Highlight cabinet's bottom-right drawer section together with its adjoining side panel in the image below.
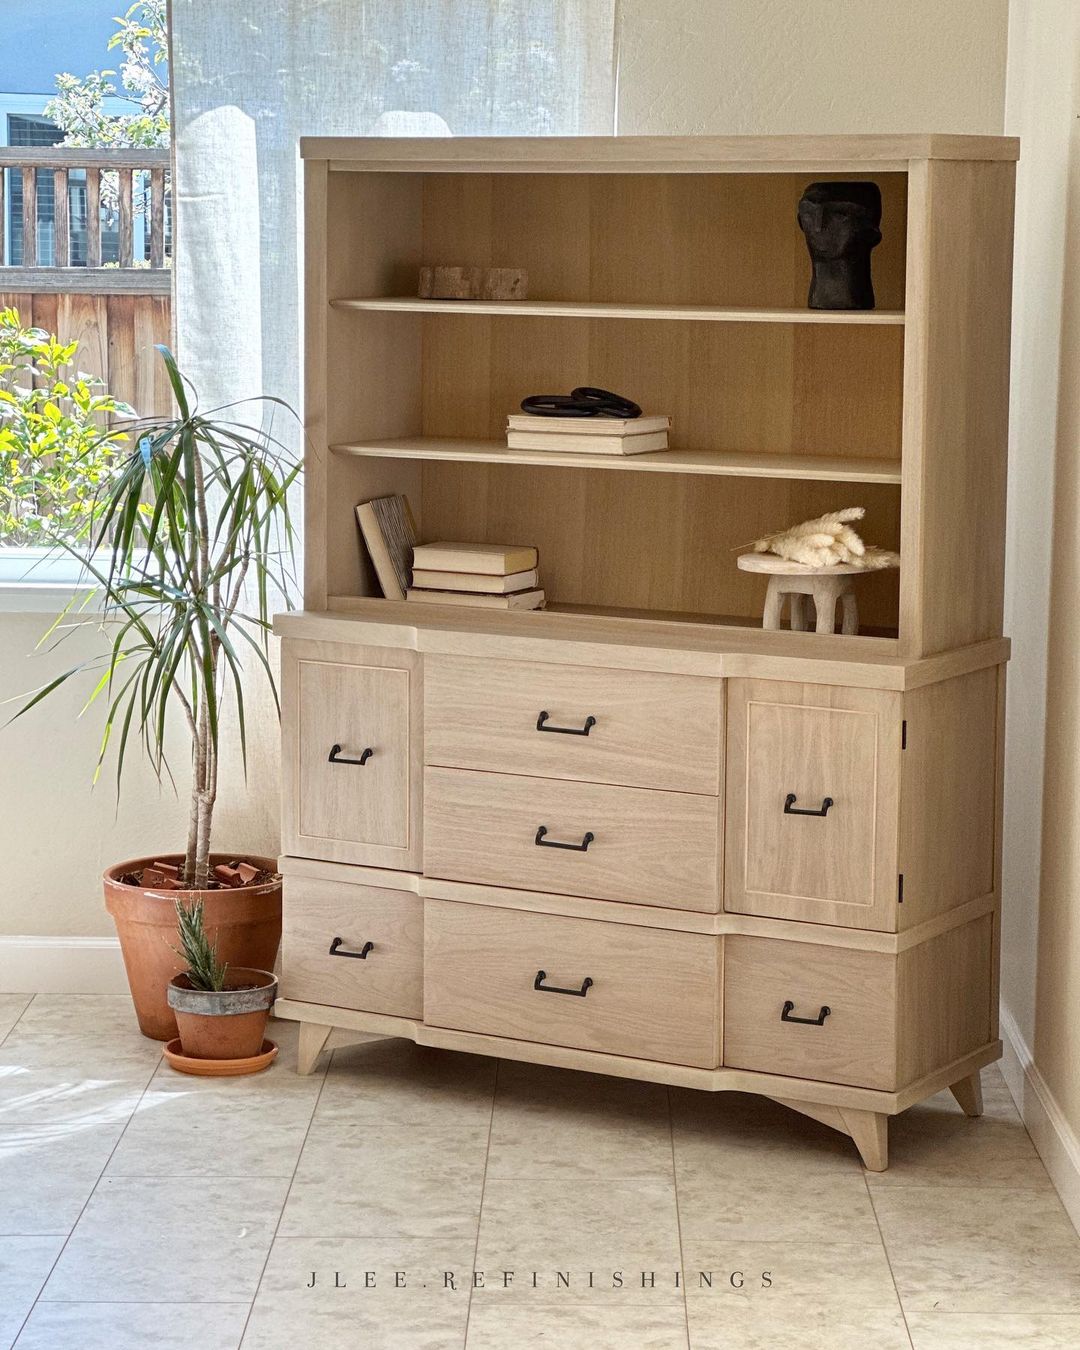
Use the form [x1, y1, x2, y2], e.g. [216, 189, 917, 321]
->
[724, 914, 994, 1091]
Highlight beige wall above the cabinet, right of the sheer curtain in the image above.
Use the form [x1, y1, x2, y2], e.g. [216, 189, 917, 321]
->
[618, 0, 1008, 135]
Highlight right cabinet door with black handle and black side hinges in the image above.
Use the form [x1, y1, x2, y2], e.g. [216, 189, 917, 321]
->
[725, 679, 900, 932]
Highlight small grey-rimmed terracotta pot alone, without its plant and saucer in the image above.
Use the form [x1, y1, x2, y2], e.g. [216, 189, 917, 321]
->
[169, 967, 278, 1060]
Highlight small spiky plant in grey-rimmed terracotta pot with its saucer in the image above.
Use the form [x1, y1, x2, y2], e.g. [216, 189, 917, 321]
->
[166, 899, 278, 1075]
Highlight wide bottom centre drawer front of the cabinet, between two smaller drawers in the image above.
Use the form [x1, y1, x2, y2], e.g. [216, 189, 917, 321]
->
[424, 900, 720, 1068]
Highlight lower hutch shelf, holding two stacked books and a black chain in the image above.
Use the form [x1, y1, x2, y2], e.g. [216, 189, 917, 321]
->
[331, 436, 900, 483]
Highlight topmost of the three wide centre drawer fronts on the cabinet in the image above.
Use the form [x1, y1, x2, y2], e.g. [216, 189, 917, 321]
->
[424, 656, 722, 794]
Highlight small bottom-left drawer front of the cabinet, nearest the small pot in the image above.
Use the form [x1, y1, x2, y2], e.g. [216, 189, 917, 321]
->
[281, 878, 424, 1018]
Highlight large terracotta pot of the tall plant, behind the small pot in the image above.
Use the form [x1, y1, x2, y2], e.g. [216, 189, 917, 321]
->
[103, 853, 281, 1041]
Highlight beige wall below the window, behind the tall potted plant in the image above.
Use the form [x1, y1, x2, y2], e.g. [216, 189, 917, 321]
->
[0, 613, 278, 937]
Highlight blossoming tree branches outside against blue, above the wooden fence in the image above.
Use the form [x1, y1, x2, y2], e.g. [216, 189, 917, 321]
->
[45, 0, 169, 149]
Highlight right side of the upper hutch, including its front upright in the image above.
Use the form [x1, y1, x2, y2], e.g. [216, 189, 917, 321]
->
[900, 162, 1015, 655]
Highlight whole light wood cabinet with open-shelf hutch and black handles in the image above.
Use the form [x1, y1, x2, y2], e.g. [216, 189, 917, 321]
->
[277, 135, 1018, 1169]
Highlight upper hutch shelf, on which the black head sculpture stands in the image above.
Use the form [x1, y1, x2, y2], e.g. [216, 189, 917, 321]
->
[331, 296, 905, 324]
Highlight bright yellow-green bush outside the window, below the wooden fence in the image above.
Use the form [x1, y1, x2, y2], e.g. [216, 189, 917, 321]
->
[0, 309, 135, 547]
